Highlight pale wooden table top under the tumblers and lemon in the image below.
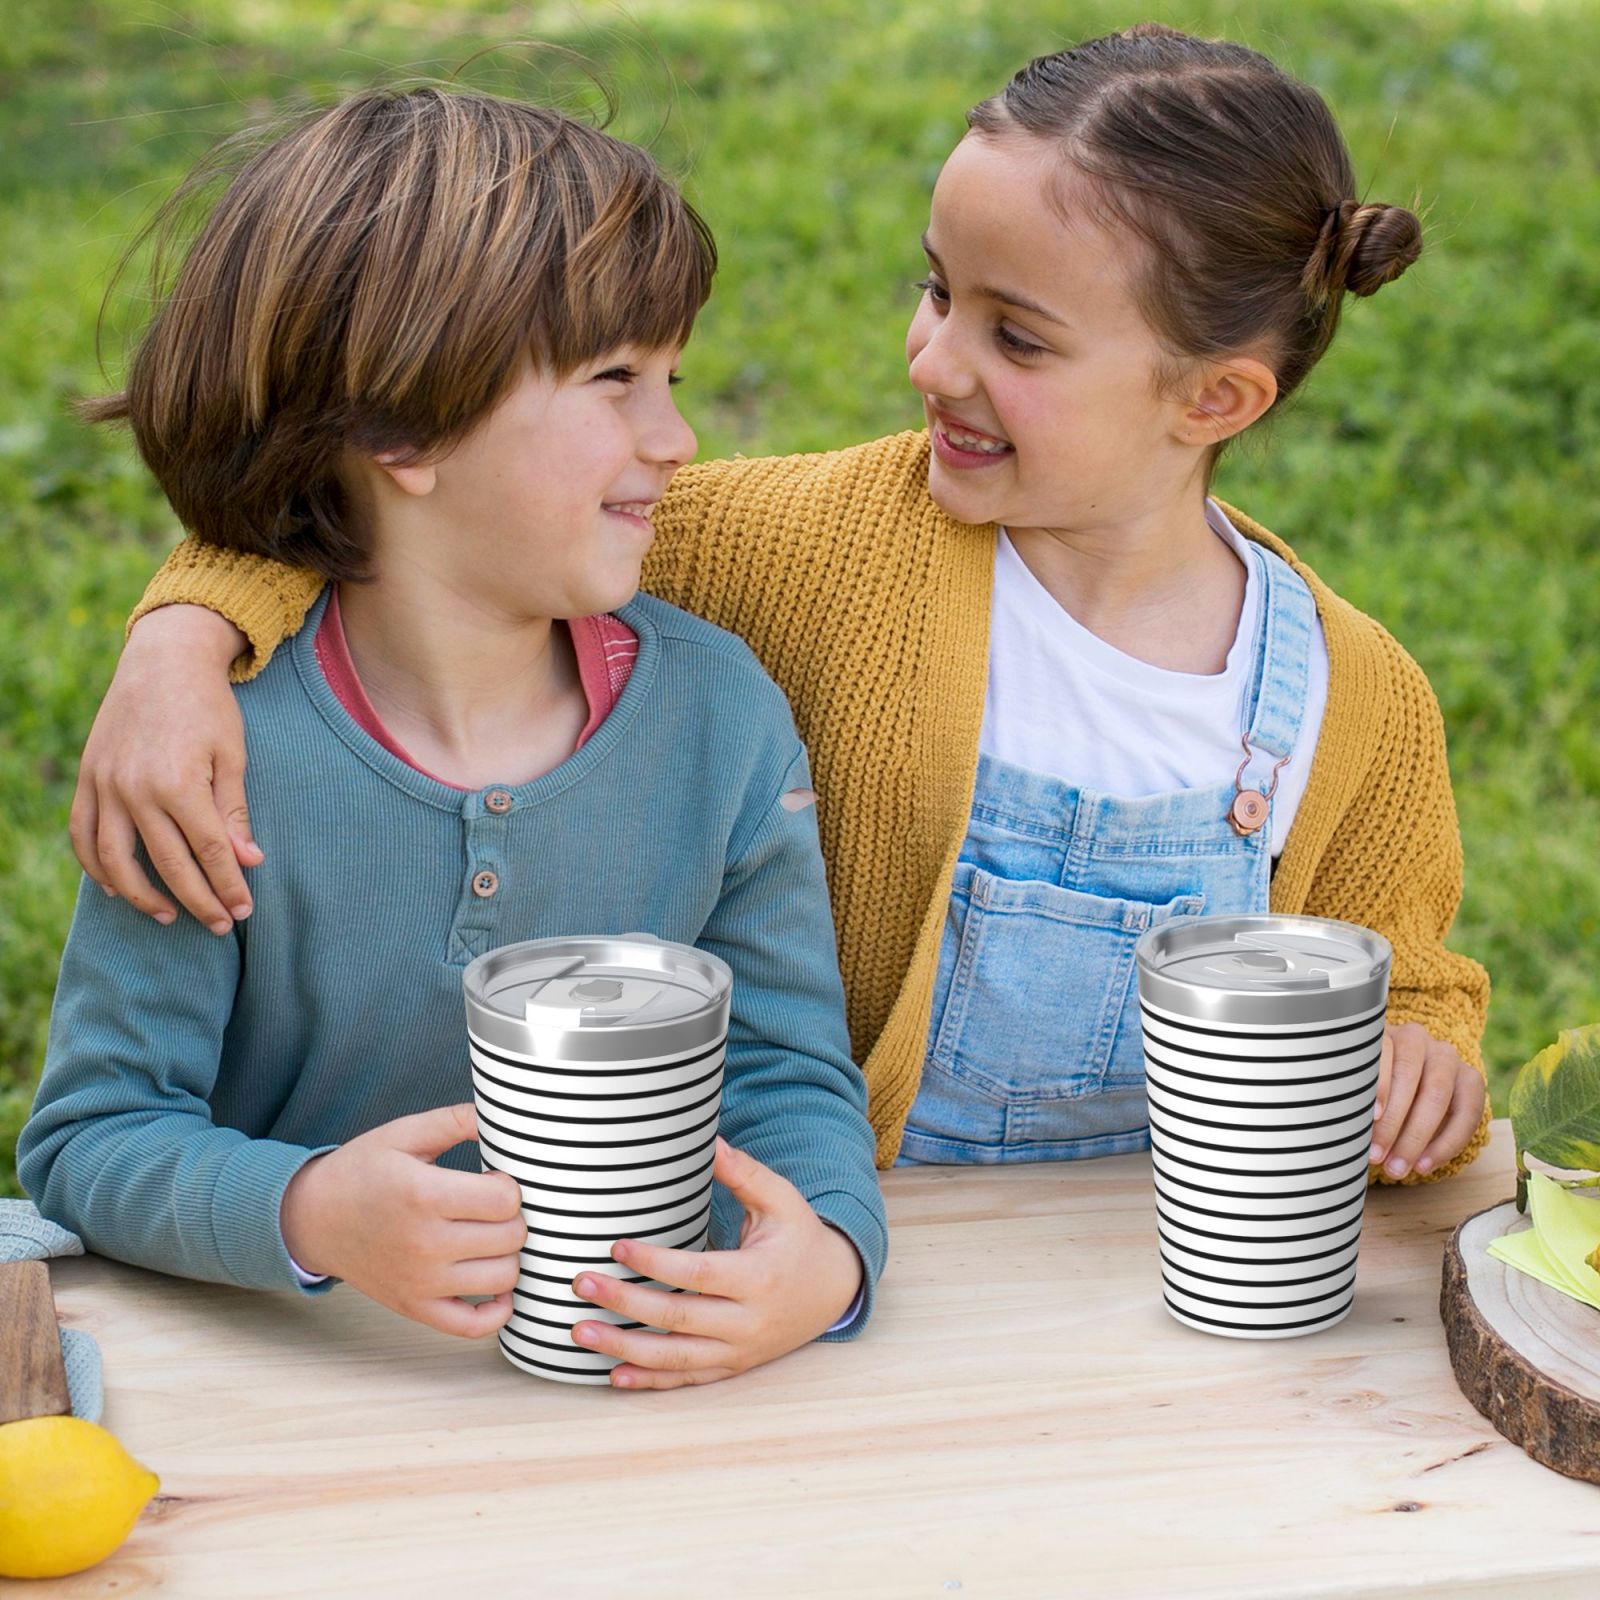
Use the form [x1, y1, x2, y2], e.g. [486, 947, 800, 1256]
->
[34, 1123, 1600, 1600]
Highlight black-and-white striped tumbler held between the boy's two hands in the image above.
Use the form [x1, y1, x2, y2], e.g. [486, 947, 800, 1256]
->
[464, 933, 733, 1384]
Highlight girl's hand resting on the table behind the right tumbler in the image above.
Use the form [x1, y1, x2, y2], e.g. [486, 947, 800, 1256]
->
[1370, 1022, 1485, 1178]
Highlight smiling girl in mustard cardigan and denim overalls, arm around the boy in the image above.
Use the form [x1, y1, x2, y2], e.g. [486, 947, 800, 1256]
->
[62, 26, 1488, 1181]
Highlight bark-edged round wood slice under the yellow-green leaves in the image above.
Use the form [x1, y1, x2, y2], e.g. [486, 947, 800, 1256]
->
[1438, 1200, 1600, 1483]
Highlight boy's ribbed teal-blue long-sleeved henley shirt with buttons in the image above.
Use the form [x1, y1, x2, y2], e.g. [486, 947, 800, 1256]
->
[18, 595, 886, 1336]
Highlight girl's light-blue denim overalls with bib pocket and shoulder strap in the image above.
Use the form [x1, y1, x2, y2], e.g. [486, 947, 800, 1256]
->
[899, 544, 1315, 1165]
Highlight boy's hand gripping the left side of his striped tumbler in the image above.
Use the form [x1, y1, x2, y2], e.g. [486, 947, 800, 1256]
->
[282, 1106, 528, 1339]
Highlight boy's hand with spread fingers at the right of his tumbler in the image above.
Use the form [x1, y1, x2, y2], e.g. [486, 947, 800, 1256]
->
[573, 1139, 861, 1389]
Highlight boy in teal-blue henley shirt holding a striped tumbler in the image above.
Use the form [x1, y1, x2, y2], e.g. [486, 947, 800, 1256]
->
[18, 88, 885, 1387]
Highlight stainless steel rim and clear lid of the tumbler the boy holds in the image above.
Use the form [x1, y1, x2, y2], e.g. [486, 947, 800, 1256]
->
[462, 933, 733, 1061]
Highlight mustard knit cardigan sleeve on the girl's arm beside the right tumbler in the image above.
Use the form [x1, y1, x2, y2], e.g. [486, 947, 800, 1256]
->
[1306, 629, 1490, 1182]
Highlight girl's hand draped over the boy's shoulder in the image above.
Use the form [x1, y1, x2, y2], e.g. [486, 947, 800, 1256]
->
[70, 605, 262, 934]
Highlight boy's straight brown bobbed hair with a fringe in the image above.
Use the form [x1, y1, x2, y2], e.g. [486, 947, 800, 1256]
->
[80, 86, 717, 579]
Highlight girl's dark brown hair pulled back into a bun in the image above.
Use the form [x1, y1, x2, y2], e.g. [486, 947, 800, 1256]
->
[966, 22, 1422, 425]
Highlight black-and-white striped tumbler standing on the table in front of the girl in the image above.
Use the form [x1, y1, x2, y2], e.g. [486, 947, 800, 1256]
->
[1138, 915, 1390, 1339]
